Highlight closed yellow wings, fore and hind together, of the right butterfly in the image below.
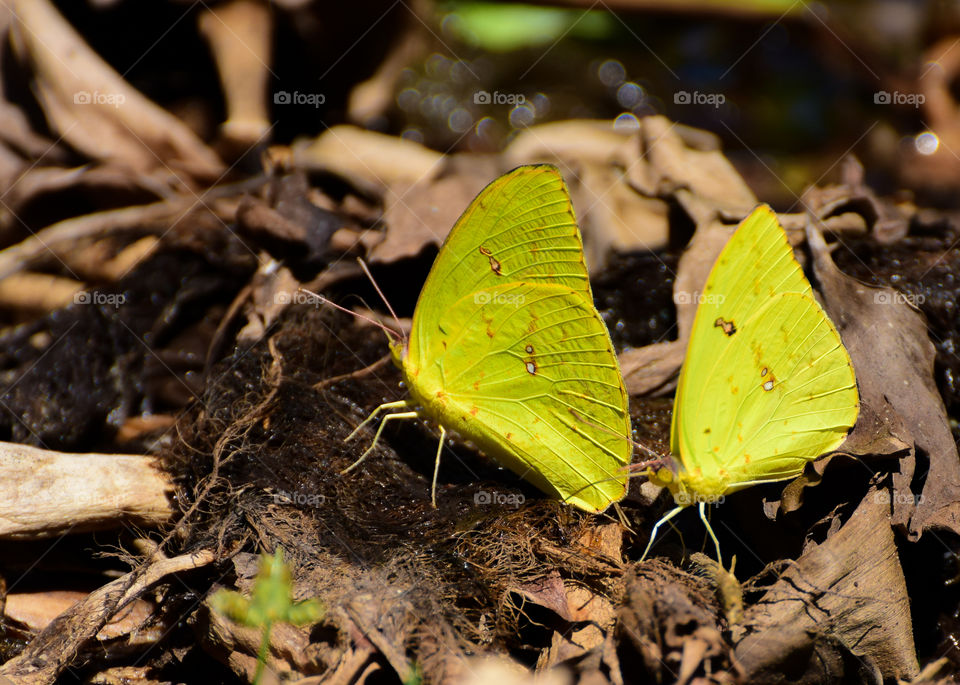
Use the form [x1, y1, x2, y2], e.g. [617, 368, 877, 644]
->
[671, 206, 859, 495]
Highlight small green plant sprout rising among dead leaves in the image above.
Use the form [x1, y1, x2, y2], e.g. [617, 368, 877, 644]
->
[210, 547, 323, 685]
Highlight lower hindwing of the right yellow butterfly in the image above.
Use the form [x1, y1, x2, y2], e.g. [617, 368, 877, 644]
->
[685, 293, 858, 486]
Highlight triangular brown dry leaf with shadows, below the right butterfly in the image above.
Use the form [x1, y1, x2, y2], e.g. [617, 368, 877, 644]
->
[735, 490, 917, 683]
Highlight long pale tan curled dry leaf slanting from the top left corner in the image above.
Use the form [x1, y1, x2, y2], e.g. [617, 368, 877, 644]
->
[12, 0, 223, 180]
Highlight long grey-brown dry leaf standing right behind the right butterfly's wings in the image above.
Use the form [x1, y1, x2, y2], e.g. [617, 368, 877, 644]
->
[807, 226, 960, 539]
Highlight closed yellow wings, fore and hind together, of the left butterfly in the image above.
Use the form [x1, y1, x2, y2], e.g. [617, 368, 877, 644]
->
[402, 165, 632, 511]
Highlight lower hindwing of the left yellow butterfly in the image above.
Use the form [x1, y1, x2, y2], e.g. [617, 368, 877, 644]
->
[411, 282, 632, 511]
